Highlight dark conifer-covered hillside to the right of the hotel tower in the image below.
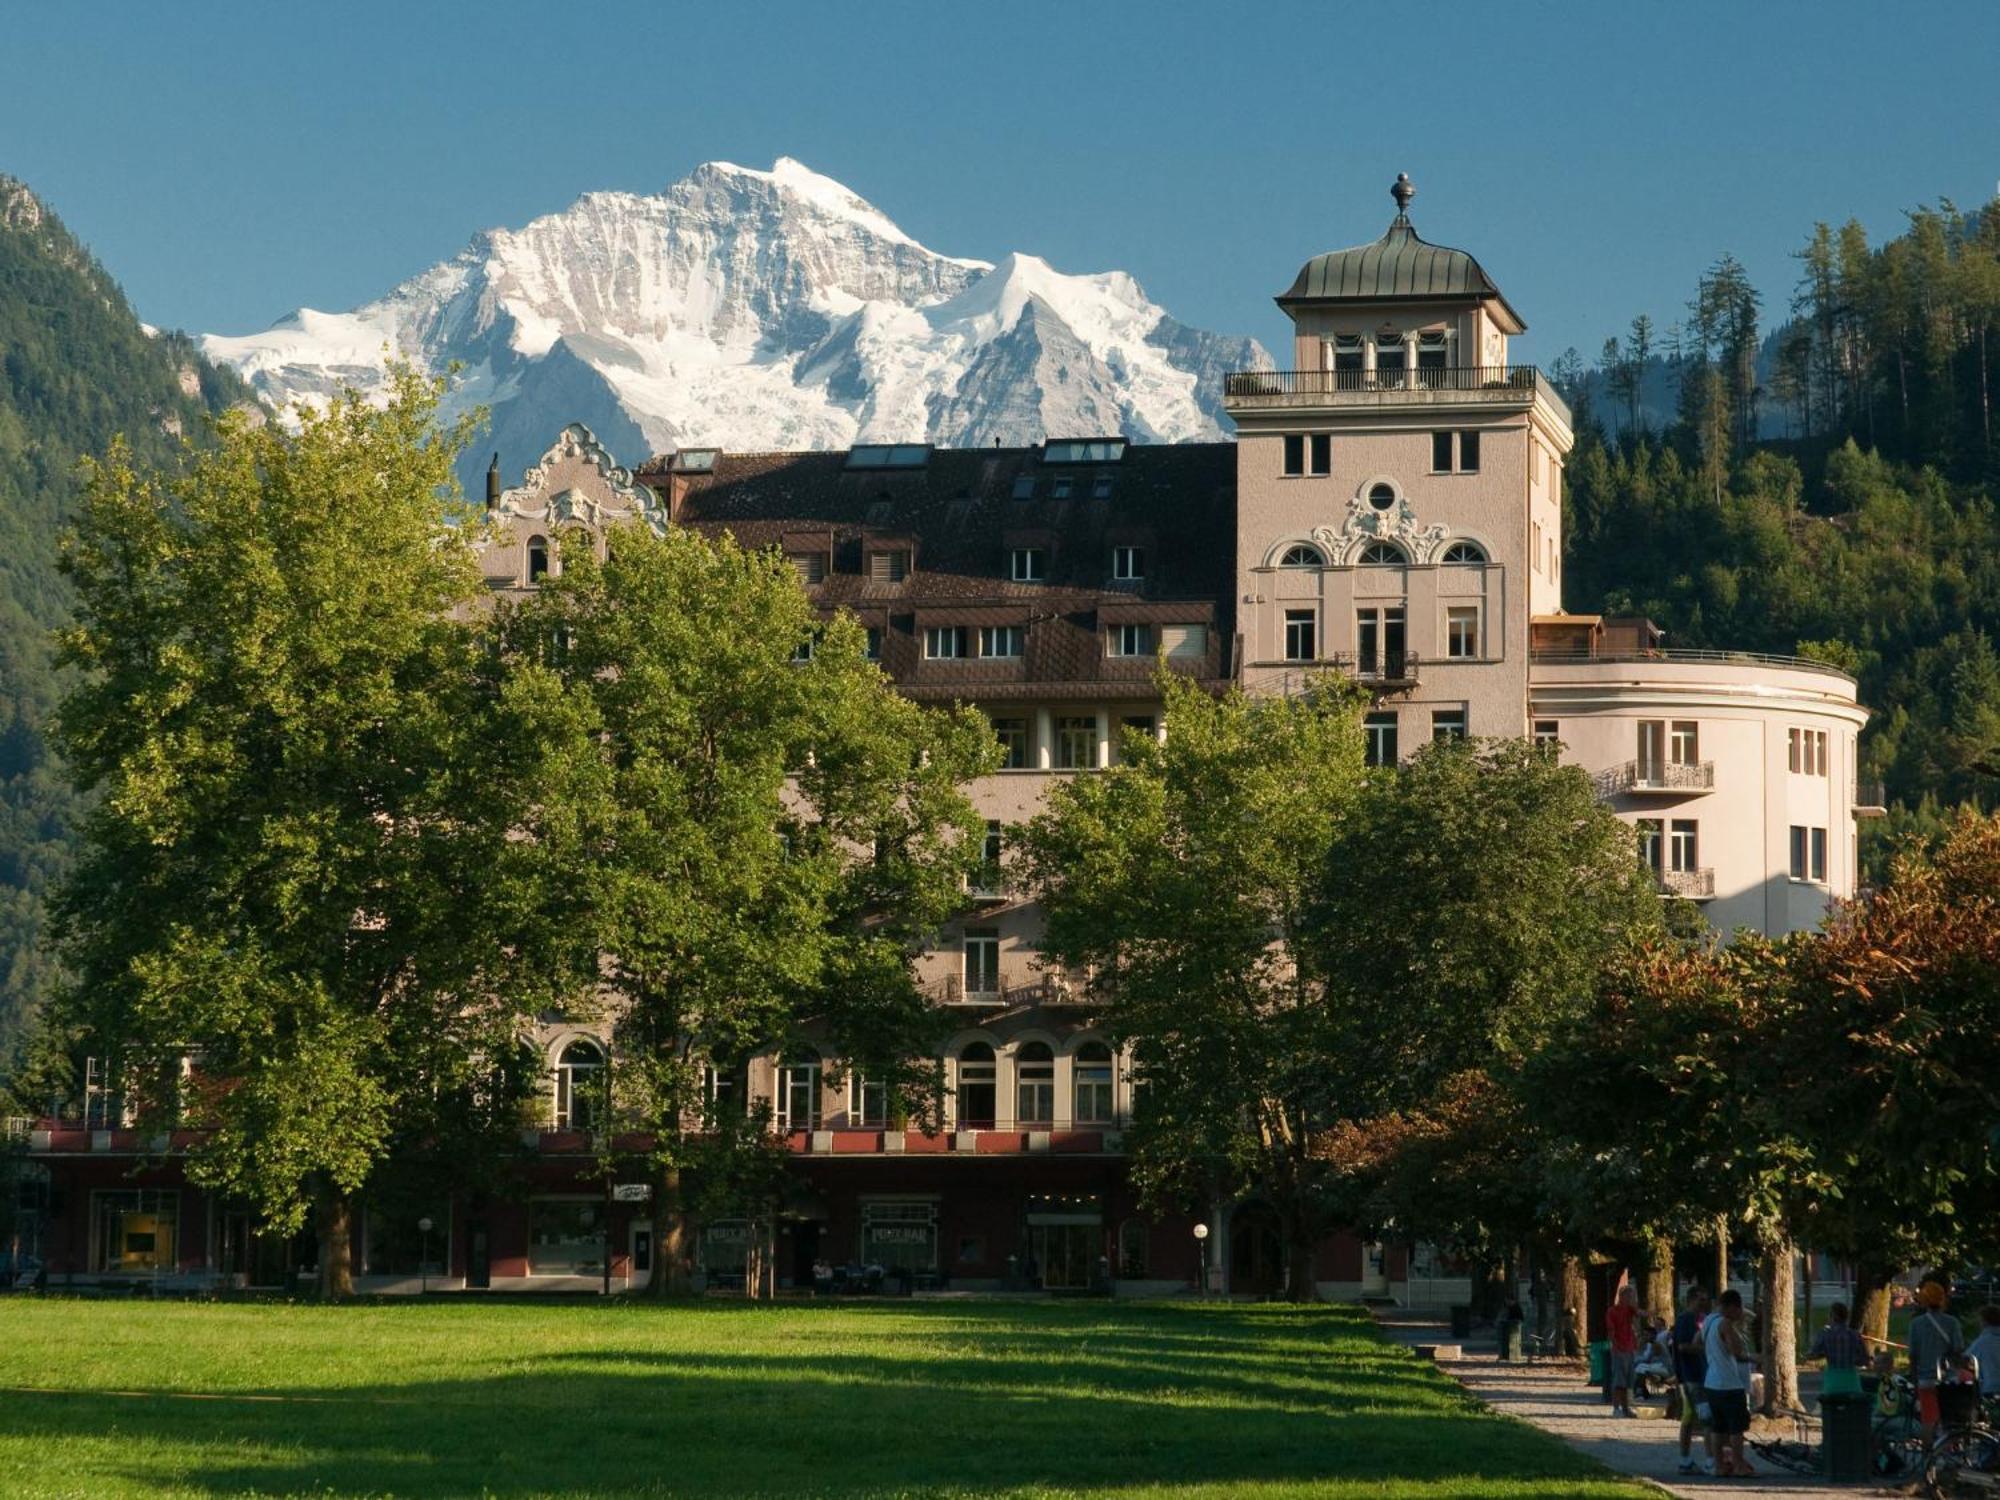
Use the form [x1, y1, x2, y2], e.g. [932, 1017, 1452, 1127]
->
[1562, 202, 2000, 868]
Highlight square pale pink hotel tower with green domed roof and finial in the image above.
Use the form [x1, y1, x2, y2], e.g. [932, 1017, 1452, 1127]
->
[1224, 176, 1572, 760]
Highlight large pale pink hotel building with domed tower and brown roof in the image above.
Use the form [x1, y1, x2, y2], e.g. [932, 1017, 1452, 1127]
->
[15, 178, 1874, 1300]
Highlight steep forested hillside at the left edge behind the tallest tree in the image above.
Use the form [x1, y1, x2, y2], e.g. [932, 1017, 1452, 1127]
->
[0, 176, 248, 1074]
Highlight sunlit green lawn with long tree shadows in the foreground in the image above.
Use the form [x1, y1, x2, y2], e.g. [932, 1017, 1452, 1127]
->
[0, 1298, 1646, 1500]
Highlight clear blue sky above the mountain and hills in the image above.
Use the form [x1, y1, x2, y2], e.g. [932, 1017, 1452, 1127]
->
[0, 0, 2000, 360]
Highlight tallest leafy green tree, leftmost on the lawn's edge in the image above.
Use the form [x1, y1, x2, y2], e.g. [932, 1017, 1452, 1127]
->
[56, 370, 532, 1296]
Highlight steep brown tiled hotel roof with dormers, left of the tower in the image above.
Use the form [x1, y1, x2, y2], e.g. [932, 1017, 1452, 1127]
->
[636, 442, 1236, 698]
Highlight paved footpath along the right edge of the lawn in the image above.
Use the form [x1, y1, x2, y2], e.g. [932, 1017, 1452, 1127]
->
[1376, 1308, 1908, 1500]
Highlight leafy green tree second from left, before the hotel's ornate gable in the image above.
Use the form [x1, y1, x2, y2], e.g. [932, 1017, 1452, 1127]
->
[500, 526, 998, 1296]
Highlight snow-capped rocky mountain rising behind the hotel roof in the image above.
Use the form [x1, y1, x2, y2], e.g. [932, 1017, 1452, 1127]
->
[202, 158, 1270, 484]
